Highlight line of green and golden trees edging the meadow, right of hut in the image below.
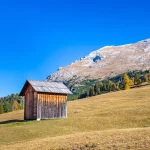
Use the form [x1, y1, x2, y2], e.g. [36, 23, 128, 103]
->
[72, 70, 150, 99]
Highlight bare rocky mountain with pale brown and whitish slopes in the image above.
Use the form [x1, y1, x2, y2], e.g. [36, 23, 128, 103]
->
[47, 39, 150, 82]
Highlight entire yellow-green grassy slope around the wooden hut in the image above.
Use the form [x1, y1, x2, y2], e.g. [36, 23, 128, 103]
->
[0, 86, 150, 149]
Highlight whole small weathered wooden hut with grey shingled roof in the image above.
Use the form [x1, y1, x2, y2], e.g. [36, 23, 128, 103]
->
[20, 80, 72, 120]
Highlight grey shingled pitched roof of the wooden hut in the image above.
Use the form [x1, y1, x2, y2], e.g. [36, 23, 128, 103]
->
[20, 80, 72, 96]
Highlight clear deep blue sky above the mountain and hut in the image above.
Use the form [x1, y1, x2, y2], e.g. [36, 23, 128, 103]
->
[0, 0, 150, 97]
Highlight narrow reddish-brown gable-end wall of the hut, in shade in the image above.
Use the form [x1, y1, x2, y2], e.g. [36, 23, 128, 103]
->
[24, 85, 37, 120]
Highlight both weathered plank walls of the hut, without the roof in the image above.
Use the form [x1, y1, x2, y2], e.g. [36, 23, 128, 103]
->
[24, 85, 67, 120]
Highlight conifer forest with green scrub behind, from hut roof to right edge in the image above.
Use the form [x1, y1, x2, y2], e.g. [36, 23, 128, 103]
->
[66, 70, 150, 100]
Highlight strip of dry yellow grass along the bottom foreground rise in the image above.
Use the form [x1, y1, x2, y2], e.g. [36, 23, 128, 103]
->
[2, 128, 150, 150]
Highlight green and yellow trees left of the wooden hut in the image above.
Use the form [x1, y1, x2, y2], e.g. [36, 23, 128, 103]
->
[0, 94, 24, 114]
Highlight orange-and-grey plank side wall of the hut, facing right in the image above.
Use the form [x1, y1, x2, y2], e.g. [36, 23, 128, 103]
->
[37, 93, 67, 119]
